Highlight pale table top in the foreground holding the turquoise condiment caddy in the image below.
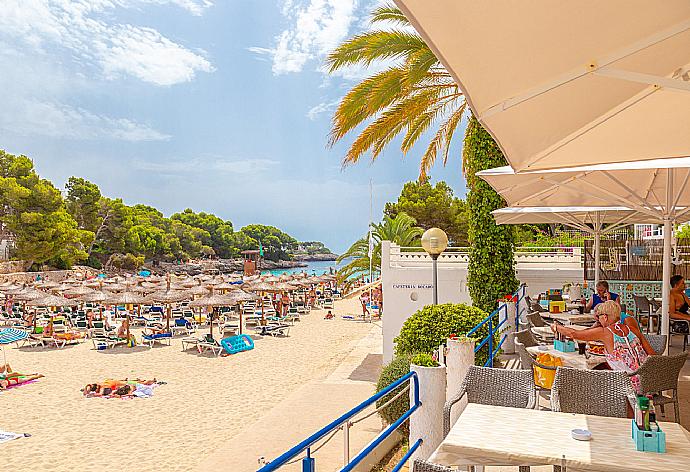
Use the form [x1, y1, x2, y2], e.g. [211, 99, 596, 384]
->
[429, 403, 690, 472]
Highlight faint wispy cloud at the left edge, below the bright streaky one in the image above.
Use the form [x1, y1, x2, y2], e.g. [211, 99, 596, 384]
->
[0, 99, 170, 142]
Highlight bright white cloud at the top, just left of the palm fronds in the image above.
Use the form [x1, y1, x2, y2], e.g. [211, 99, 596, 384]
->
[250, 0, 358, 75]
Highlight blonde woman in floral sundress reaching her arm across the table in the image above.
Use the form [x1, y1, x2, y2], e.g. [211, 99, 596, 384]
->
[551, 300, 656, 392]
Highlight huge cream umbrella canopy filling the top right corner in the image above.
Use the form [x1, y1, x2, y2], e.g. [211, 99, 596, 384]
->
[395, 0, 690, 171]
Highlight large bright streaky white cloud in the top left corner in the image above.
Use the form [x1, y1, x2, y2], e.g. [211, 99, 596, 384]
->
[0, 0, 214, 85]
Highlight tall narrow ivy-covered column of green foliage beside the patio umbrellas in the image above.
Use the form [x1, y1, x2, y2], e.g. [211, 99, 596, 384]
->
[463, 116, 519, 312]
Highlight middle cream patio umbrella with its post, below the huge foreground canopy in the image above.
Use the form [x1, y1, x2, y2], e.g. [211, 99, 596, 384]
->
[477, 157, 690, 340]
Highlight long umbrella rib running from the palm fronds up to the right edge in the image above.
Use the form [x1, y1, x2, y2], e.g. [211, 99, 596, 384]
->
[479, 19, 690, 121]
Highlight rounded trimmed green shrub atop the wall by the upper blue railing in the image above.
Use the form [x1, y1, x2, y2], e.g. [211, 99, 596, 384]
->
[394, 303, 492, 365]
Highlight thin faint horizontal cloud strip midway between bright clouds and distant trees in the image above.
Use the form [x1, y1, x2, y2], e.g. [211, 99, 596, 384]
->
[133, 158, 279, 176]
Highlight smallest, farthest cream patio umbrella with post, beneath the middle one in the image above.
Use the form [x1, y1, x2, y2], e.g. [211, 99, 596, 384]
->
[491, 206, 690, 286]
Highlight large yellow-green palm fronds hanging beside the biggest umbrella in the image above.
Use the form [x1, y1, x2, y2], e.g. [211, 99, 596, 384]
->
[326, 4, 467, 179]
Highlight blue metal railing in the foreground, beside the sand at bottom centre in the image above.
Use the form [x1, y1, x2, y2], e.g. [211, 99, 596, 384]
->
[258, 372, 422, 472]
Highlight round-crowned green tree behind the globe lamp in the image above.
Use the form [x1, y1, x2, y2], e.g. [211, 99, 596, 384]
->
[384, 179, 469, 246]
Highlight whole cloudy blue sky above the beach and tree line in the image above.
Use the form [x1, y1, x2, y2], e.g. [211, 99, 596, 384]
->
[0, 0, 465, 252]
